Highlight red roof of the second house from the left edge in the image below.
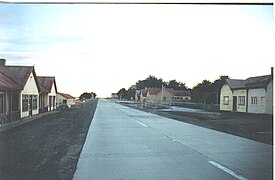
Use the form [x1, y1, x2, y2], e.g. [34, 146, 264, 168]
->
[37, 76, 56, 93]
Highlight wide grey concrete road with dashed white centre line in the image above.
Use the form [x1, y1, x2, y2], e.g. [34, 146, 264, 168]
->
[74, 99, 273, 180]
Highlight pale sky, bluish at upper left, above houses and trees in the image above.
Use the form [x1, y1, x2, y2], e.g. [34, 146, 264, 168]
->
[0, 3, 275, 97]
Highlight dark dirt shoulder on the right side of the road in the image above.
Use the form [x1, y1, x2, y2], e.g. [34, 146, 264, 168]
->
[125, 104, 273, 144]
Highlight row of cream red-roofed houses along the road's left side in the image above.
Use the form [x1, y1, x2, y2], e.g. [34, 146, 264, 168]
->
[0, 59, 75, 125]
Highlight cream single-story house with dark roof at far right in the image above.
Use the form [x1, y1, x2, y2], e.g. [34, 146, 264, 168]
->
[220, 69, 273, 114]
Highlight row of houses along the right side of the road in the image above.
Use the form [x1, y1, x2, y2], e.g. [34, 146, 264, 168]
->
[126, 68, 273, 114]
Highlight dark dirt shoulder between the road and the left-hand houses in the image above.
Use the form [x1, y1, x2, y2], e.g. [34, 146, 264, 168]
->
[0, 100, 97, 180]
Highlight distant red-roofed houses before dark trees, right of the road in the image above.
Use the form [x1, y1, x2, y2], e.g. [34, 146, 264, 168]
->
[135, 87, 191, 104]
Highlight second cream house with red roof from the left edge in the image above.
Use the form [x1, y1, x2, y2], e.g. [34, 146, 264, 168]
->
[37, 76, 57, 113]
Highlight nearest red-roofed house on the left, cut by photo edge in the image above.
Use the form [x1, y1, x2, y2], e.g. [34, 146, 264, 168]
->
[0, 59, 40, 124]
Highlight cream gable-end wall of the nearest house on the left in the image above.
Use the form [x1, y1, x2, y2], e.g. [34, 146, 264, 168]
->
[20, 73, 39, 118]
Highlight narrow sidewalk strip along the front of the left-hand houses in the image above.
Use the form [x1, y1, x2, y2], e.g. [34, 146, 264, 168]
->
[0, 110, 59, 133]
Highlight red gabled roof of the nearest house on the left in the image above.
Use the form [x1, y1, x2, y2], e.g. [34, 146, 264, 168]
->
[0, 66, 40, 91]
